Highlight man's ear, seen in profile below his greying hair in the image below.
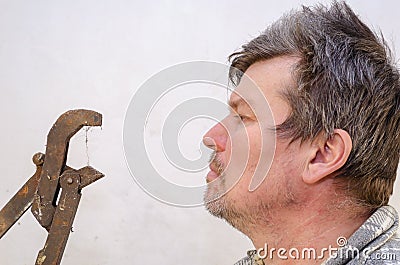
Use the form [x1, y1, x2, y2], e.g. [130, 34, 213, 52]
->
[303, 129, 353, 184]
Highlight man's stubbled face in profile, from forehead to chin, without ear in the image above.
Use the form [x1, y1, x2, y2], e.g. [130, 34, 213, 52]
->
[204, 57, 302, 229]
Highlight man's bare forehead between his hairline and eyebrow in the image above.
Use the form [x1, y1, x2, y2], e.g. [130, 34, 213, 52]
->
[230, 56, 299, 105]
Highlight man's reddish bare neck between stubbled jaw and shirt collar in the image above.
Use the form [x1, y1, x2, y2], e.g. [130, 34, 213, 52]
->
[246, 197, 369, 264]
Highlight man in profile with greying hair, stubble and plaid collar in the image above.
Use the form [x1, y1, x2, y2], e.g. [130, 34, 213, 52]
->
[203, 2, 400, 264]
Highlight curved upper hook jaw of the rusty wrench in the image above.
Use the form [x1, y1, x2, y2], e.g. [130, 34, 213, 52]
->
[31, 109, 102, 230]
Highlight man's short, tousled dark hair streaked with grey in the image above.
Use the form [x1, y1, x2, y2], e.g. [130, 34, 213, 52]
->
[229, 1, 400, 210]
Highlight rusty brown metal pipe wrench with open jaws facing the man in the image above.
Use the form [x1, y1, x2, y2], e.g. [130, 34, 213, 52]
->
[0, 110, 104, 265]
